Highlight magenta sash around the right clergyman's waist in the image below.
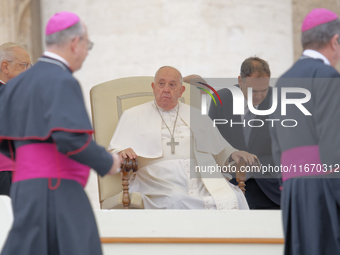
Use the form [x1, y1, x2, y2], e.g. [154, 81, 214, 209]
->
[281, 145, 330, 181]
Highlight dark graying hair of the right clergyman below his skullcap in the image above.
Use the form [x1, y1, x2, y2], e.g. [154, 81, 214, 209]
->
[301, 19, 340, 49]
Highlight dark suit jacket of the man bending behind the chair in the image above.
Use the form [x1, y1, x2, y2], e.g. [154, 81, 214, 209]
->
[209, 85, 281, 208]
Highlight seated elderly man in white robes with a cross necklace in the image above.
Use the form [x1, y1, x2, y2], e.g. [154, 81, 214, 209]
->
[109, 66, 256, 209]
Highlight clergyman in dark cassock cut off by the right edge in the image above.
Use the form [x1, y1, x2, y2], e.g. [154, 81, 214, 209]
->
[271, 8, 340, 255]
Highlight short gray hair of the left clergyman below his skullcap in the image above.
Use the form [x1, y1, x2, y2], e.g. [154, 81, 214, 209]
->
[45, 21, 85, 46]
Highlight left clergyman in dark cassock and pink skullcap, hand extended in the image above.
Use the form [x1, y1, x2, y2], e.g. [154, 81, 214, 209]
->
[0, 12, 120, 255]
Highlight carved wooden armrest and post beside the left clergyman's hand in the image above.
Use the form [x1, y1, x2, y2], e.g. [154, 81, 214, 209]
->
[120, 158, 138, 209]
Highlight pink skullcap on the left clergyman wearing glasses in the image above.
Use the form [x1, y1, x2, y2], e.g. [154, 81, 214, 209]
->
[45, 12, 80, 35]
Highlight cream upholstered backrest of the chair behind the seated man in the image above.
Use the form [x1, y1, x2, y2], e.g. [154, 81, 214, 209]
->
[90, 76, 194, 207]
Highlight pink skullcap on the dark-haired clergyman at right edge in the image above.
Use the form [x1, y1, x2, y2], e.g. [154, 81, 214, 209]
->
[301, 8, 338, 32]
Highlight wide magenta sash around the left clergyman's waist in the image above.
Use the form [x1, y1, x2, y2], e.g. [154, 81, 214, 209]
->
[13, 143, 90, 187]
